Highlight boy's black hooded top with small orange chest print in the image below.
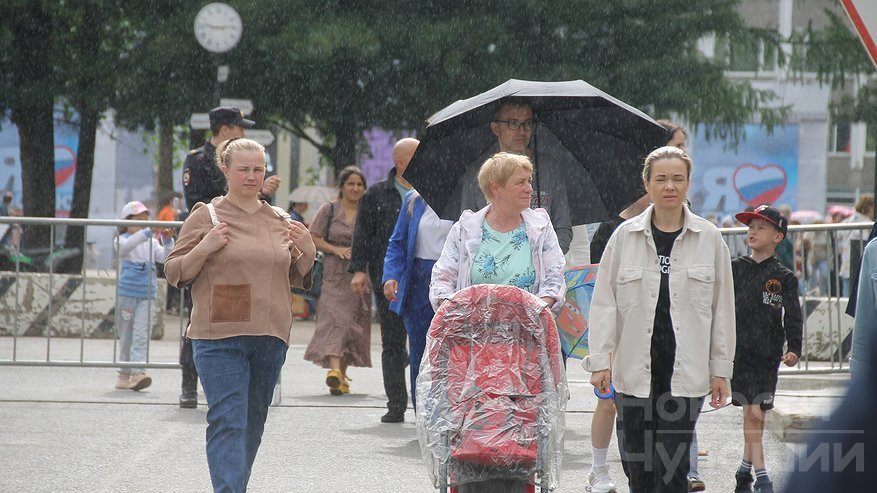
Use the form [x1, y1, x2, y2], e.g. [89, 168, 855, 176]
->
[731, 257, 803, 362]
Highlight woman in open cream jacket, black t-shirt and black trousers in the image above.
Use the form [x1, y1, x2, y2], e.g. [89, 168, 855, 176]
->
[583, 146, 736, 492]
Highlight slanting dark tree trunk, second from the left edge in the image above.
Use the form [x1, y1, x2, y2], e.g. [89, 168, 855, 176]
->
[64, 106, 100, 273]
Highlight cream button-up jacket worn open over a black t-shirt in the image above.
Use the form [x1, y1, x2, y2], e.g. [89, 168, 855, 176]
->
[582, 206, 737, 398]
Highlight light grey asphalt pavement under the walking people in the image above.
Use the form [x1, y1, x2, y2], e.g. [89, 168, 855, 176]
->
[0, 319, 842, 492]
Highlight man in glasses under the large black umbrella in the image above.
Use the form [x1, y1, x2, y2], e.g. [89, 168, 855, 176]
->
[460, 98, 572, 253]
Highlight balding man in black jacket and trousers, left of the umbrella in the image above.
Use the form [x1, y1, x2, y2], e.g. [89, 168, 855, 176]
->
[347, 138, 420, 423]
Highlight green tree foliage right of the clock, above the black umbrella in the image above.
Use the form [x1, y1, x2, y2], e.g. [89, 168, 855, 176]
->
[234, 0, 786, 174]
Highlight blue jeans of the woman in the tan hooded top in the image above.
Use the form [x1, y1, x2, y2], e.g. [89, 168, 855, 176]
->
[192, 336, 287, 493]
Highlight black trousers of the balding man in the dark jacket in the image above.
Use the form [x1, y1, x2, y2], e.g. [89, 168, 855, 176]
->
[372, 279, 408, 413]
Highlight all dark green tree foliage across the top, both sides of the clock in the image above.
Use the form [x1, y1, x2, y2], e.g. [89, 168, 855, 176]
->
[0, 0, 785, 211]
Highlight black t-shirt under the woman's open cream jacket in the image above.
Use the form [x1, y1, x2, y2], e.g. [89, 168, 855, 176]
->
[651, 224, 682, 393]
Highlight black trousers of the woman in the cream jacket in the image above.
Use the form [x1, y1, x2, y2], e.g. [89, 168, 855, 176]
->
[615, 390, 703, 493]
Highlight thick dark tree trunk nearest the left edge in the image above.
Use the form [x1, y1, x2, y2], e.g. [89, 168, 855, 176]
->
[12, 103, 55, 248]
